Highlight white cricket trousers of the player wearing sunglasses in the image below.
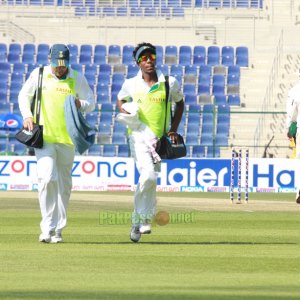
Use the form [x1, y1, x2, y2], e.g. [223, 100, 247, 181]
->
[129, 131, 160, 224]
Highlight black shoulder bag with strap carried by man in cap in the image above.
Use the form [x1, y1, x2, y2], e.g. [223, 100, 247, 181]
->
[16, 67, 44, 148]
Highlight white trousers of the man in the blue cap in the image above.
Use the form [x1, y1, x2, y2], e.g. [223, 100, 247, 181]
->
[35, 143, 75, 234]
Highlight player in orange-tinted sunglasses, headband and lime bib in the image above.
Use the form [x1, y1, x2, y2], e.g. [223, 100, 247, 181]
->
[117, 43, 184, 242]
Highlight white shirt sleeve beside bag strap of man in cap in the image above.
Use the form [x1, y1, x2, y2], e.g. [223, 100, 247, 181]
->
[18, 68, 39, 120]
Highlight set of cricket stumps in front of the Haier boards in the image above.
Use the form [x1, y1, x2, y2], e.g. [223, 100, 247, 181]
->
[230, 148, 249, 203]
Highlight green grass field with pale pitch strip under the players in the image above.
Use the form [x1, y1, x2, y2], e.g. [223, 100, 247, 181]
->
[0, 192, 300, 300]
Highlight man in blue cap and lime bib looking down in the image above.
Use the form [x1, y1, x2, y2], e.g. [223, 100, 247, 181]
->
[19, 44, 95, 243]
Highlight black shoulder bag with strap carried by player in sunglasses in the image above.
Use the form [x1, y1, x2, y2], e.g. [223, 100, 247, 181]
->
[156, 76, 186, 159]
